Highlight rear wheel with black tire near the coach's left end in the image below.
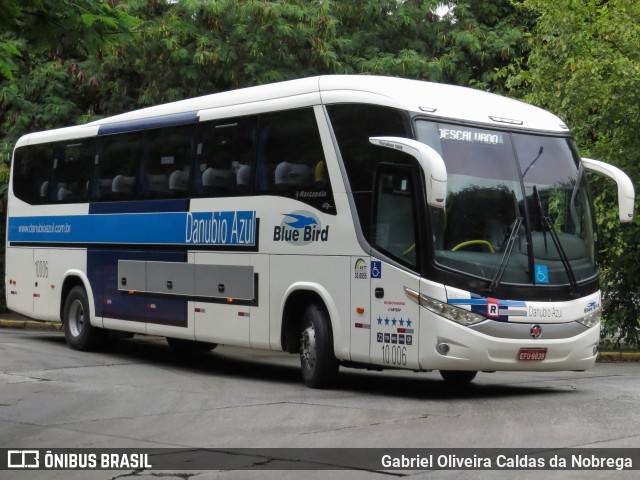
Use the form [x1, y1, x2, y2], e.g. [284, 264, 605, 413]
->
[62, 286, 104, 351]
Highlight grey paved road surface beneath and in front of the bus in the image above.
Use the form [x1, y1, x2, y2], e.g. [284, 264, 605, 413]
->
[0, 329, 640, 480]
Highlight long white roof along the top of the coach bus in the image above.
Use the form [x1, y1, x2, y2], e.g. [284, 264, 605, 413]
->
[16, 75, 568, 146]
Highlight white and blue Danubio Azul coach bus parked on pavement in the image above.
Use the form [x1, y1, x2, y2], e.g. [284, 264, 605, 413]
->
[5, 76, 634, 387]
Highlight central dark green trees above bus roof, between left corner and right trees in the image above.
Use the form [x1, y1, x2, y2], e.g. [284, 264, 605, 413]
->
[76, 0, 525, 110]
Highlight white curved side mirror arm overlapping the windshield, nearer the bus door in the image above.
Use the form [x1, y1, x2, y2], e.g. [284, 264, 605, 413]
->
[369, 137, 447, 208]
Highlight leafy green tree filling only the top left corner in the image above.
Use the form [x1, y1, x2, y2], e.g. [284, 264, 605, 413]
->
[0, 0, 136, 159]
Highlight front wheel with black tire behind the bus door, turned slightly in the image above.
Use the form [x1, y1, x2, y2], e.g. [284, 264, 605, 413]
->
[300, 304, 340, 388]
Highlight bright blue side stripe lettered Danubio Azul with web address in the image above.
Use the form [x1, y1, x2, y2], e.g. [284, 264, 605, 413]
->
[7, 210, 257, 247]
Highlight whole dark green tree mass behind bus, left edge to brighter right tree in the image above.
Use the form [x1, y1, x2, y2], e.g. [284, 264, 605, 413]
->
[0, 0, 526, 156]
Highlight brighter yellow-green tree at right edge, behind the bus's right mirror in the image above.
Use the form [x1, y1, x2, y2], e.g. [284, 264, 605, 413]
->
[503, 0, 640, 345]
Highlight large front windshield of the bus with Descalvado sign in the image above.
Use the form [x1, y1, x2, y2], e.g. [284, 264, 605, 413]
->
[416, 120, 597, 289]
